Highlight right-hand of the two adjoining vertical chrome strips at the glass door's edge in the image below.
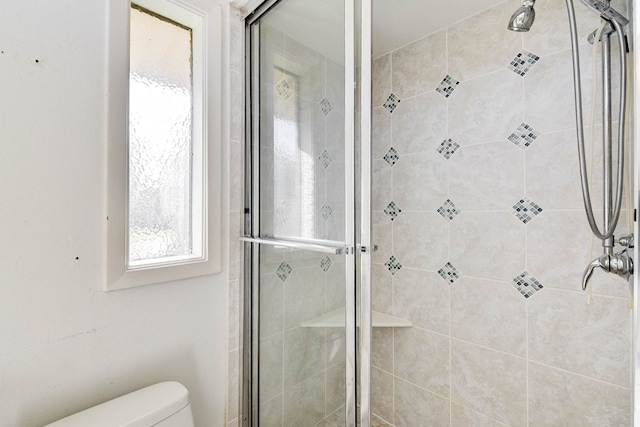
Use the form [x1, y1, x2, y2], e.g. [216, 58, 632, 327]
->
[358, 0, 377, 427]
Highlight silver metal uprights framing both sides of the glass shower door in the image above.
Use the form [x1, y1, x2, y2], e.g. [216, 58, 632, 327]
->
[240, 0, 374, 427]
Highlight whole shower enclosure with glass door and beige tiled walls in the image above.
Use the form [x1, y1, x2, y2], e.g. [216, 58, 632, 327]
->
[242, 0, 638, 427]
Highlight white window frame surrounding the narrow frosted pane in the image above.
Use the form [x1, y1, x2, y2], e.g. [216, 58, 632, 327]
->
[104, 0, 222, 291]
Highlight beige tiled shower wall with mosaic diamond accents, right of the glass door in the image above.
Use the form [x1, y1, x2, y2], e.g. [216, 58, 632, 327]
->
[372, 0, 631, 426]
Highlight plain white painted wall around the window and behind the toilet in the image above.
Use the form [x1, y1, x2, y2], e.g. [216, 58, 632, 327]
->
[0, 0, 229, 427]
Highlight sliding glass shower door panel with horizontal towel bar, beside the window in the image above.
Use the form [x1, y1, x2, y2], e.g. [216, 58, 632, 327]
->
[243, 0, 356, 427]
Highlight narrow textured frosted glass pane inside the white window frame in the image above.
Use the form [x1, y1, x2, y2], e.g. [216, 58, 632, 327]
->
[128, 5, 196, 268]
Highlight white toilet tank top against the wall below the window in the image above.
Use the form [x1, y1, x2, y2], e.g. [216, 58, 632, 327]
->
[45, 381, 194, 427]
